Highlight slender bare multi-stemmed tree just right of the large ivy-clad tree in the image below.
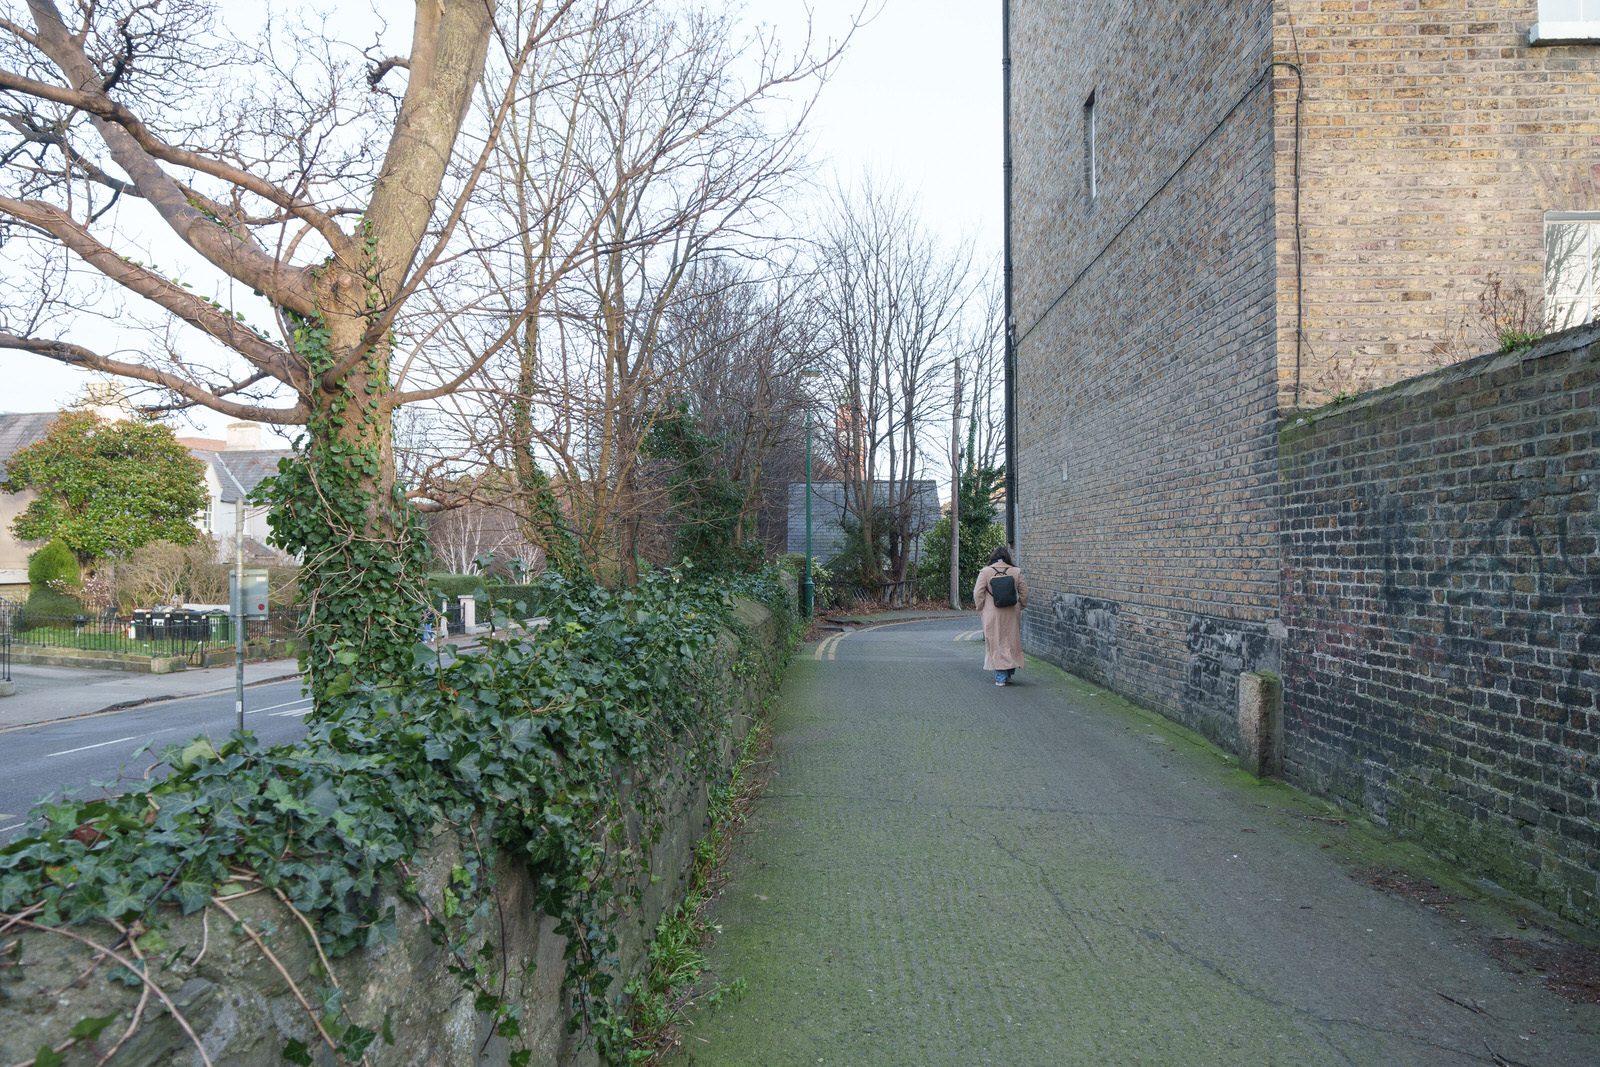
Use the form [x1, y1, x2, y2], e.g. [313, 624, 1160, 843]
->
[403, 8, 843, 579]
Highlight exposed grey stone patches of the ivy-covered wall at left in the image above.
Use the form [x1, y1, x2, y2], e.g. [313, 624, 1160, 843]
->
[0, 603, 786, 1067]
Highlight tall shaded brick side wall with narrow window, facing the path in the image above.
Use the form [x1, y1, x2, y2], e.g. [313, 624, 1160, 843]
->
[1011, 0, 1280, 741]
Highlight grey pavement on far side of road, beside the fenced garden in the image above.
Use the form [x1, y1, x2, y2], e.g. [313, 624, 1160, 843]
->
[0, 659, 299, 729]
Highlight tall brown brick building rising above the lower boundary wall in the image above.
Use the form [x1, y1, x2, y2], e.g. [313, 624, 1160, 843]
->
[1008, 0, 1600, 737]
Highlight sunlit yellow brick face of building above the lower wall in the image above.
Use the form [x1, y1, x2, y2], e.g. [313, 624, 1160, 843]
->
[1274, 0, 1600, 408]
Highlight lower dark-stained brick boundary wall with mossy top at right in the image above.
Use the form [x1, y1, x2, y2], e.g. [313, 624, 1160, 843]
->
[1282, 326, 1600, 921]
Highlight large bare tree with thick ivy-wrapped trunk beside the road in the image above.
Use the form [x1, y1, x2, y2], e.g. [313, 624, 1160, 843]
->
[0, 0, 851, 704]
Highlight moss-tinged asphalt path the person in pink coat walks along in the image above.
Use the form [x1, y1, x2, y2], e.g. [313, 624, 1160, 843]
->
[672, 616, 1600, 1067]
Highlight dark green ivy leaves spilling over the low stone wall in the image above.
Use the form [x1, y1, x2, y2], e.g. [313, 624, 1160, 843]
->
[0, 571, 792, 1059]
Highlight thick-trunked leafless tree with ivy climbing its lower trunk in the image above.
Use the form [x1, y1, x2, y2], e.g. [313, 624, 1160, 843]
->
[0, 0, 505, 707]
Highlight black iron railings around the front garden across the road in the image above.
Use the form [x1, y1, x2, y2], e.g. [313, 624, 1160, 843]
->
[0, 600, 282, 662]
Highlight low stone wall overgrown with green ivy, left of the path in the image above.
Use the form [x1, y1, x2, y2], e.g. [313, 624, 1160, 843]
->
[0, 574, 794, 1065]
